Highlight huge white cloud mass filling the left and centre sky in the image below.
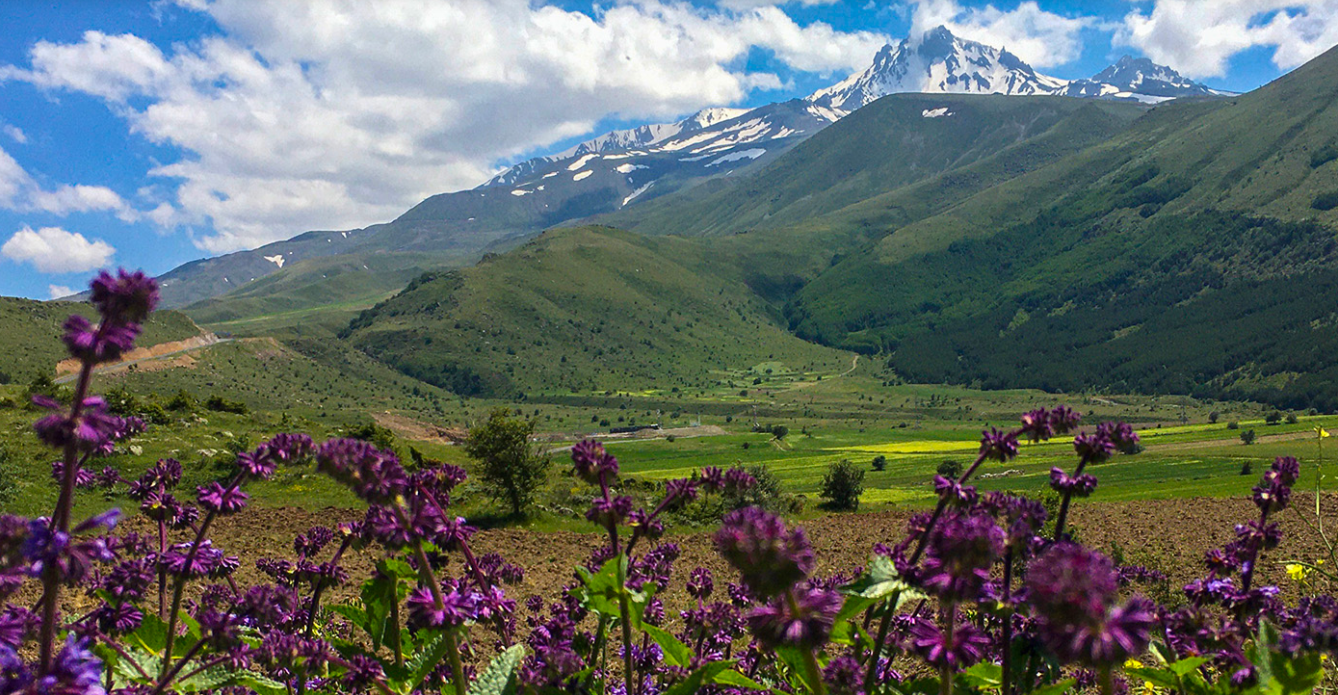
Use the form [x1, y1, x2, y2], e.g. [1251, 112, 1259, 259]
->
[10, 0, 887, 252]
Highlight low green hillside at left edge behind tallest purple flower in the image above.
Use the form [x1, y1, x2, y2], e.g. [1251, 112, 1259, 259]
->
[0, 297, 201, 384]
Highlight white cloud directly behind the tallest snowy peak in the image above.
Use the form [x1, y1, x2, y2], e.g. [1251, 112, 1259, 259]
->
[911, 0, 1096, 67]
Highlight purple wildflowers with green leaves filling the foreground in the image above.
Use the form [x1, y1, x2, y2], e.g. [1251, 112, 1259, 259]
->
[10, 277, 1338, 695]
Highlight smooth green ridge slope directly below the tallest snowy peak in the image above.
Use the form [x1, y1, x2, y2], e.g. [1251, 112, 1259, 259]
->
[602, 94, 1147, 236]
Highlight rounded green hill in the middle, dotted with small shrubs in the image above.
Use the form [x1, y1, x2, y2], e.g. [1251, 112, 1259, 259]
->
[345, 228, 850, 395]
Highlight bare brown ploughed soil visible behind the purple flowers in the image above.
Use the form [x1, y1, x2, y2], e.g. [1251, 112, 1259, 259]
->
[172, 493, 1338, 618]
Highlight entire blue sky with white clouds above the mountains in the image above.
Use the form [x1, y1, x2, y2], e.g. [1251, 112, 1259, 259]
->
[0, 0, 1338, 299]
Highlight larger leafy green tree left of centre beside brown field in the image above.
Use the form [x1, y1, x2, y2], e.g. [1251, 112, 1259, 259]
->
[464, 408, 551, 514]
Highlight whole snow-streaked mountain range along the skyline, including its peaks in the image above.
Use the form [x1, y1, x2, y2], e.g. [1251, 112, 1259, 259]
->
[149, 27, 1222, 307]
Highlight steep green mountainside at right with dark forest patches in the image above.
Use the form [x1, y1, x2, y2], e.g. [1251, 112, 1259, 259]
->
[787, 43, 1338, 410]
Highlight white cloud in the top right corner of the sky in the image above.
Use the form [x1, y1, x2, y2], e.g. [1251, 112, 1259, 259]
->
[1115, 0, 1338, 78]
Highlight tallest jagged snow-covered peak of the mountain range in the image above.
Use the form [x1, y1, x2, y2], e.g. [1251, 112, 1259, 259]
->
[808, 27, 1068, 115]
